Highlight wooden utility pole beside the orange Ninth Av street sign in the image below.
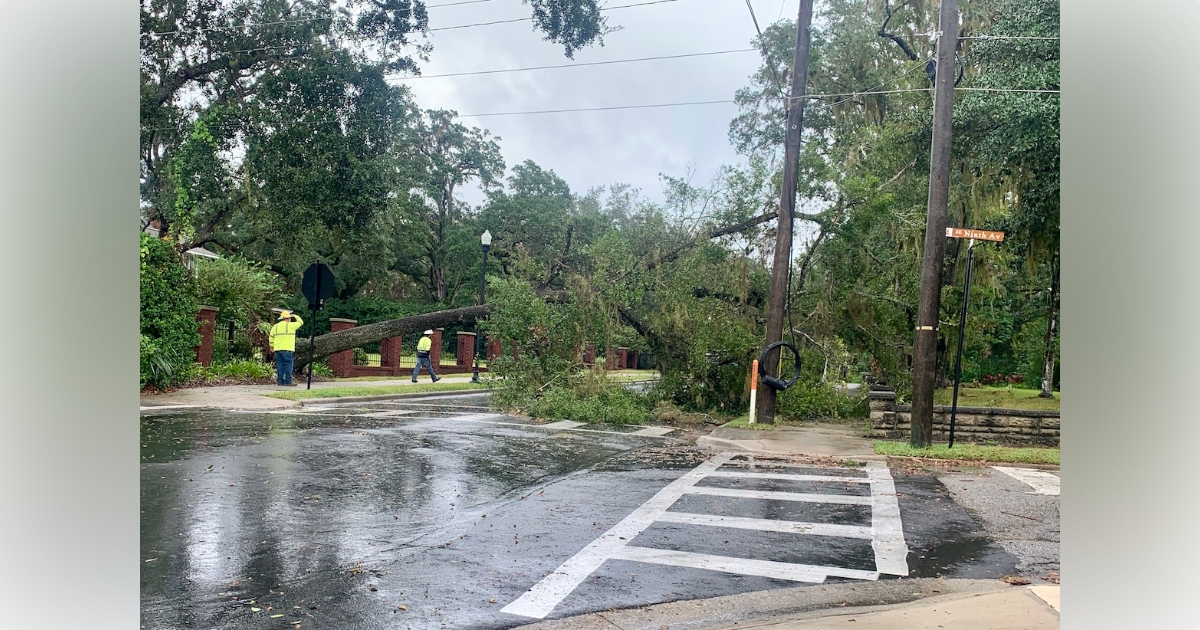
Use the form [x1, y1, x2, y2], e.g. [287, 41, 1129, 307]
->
[908, 0, 959, 446]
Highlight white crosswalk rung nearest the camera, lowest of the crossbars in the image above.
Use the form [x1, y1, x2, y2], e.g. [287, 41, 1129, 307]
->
[612, 547, 864, 584]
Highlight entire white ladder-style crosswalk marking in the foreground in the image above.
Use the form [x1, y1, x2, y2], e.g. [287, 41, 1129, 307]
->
[500, 452, 908, 619]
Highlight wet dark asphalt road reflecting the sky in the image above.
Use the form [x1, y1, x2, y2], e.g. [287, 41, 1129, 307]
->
[142, 396, 1019, 629]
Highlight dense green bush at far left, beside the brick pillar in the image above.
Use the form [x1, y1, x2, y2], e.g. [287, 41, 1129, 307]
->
[139, 233, 200, 388]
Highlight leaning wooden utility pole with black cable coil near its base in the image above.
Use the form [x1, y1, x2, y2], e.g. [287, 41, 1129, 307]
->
[758, 0, 812, 425]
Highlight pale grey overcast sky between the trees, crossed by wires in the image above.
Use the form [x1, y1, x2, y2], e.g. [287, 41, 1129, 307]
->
[397, 0, 799, 204]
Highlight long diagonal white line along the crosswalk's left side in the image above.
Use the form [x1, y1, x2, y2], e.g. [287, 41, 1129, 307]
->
[500, 454, 732, 619]
